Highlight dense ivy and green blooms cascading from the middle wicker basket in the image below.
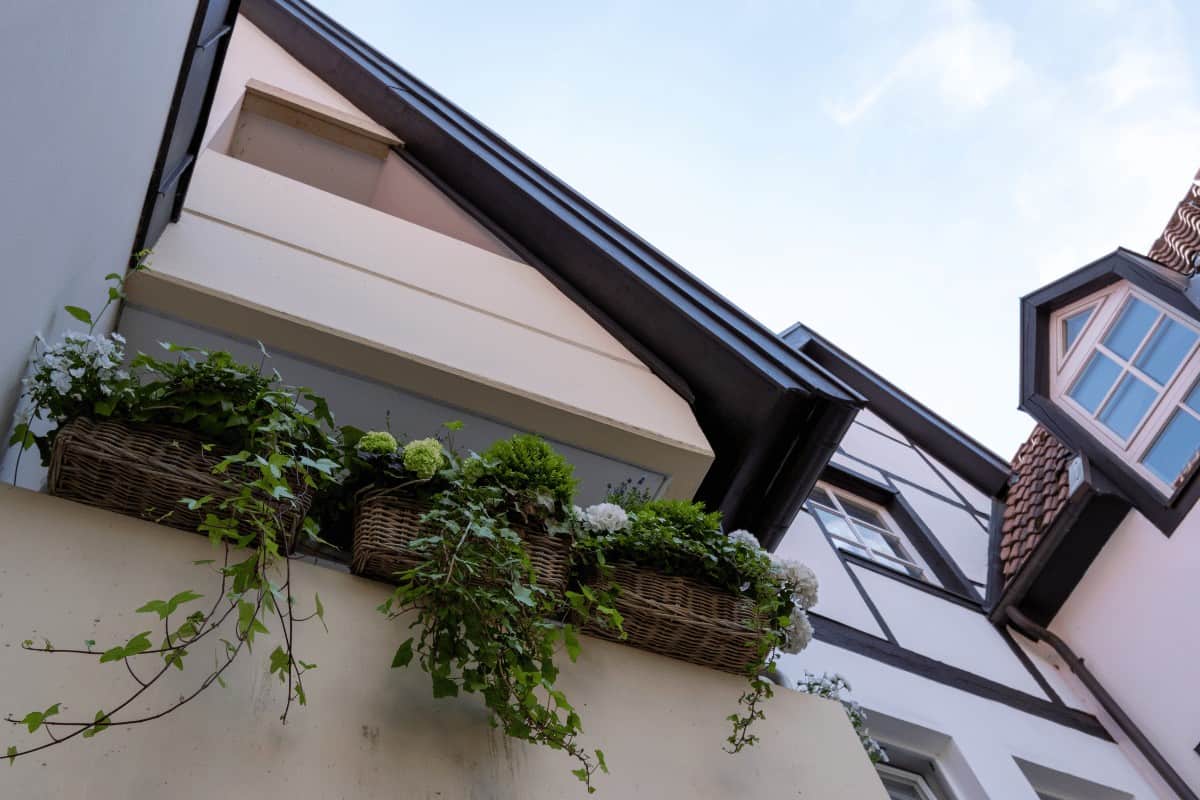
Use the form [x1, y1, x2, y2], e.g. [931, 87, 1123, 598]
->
[360, 426, 619, 793]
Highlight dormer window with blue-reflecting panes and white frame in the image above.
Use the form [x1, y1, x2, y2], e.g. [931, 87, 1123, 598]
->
[1050, 283, 1200, 497]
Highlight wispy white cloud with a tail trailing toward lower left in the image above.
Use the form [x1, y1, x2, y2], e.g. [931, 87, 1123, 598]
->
[826, 2, 1025, 125]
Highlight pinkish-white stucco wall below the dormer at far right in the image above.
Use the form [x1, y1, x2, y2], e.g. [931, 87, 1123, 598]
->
[1050, 506, 1200, 792]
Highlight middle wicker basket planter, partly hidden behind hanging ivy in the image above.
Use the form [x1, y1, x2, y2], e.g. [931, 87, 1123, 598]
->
[350, 489, 571, 597]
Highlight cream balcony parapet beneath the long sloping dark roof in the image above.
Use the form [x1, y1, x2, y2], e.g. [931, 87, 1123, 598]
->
[130, 151, 712, 497]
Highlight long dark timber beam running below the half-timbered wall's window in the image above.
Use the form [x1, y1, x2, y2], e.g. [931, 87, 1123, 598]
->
[809, 612, 1112, 741]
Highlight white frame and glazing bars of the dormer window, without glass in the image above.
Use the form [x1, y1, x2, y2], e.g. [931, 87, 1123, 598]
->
[1049, 282, 1200, 499]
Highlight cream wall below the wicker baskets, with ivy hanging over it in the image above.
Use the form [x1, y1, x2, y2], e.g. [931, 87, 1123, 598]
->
[0, 487, 884, 800]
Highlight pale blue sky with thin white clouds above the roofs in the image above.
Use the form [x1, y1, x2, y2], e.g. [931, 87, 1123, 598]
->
[314, 0, 1200, 459]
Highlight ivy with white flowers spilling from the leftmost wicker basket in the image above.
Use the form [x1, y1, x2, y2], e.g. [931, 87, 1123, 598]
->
[5, 267, 337, 762]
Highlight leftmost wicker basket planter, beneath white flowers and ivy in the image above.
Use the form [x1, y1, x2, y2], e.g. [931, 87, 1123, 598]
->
[49, 419, 312, 551]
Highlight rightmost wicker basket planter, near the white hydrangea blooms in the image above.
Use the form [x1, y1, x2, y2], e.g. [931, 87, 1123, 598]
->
[586, 564, 760, 675]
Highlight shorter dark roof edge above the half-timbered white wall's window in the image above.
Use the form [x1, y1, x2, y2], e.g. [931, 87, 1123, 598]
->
[780, 323, 1009, 497]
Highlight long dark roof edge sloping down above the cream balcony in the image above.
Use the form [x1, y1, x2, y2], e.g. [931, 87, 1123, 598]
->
[244, 0, 860, 403]
